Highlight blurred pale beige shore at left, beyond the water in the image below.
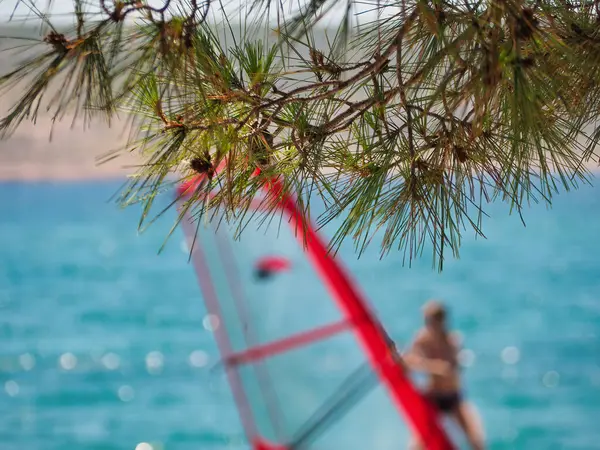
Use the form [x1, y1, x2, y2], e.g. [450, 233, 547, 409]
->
[0, 24, 140, 181]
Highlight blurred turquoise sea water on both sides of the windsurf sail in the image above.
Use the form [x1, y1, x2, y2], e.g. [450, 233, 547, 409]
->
[0, 182, 600, 450]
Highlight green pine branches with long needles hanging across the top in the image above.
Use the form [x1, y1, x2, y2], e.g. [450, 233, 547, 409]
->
[0, 0, 600, 269]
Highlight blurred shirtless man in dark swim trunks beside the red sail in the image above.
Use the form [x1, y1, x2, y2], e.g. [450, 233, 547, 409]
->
[404, 301, 484, 450]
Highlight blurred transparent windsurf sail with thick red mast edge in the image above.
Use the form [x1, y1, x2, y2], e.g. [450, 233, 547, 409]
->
[178, 173, 453, 450]
